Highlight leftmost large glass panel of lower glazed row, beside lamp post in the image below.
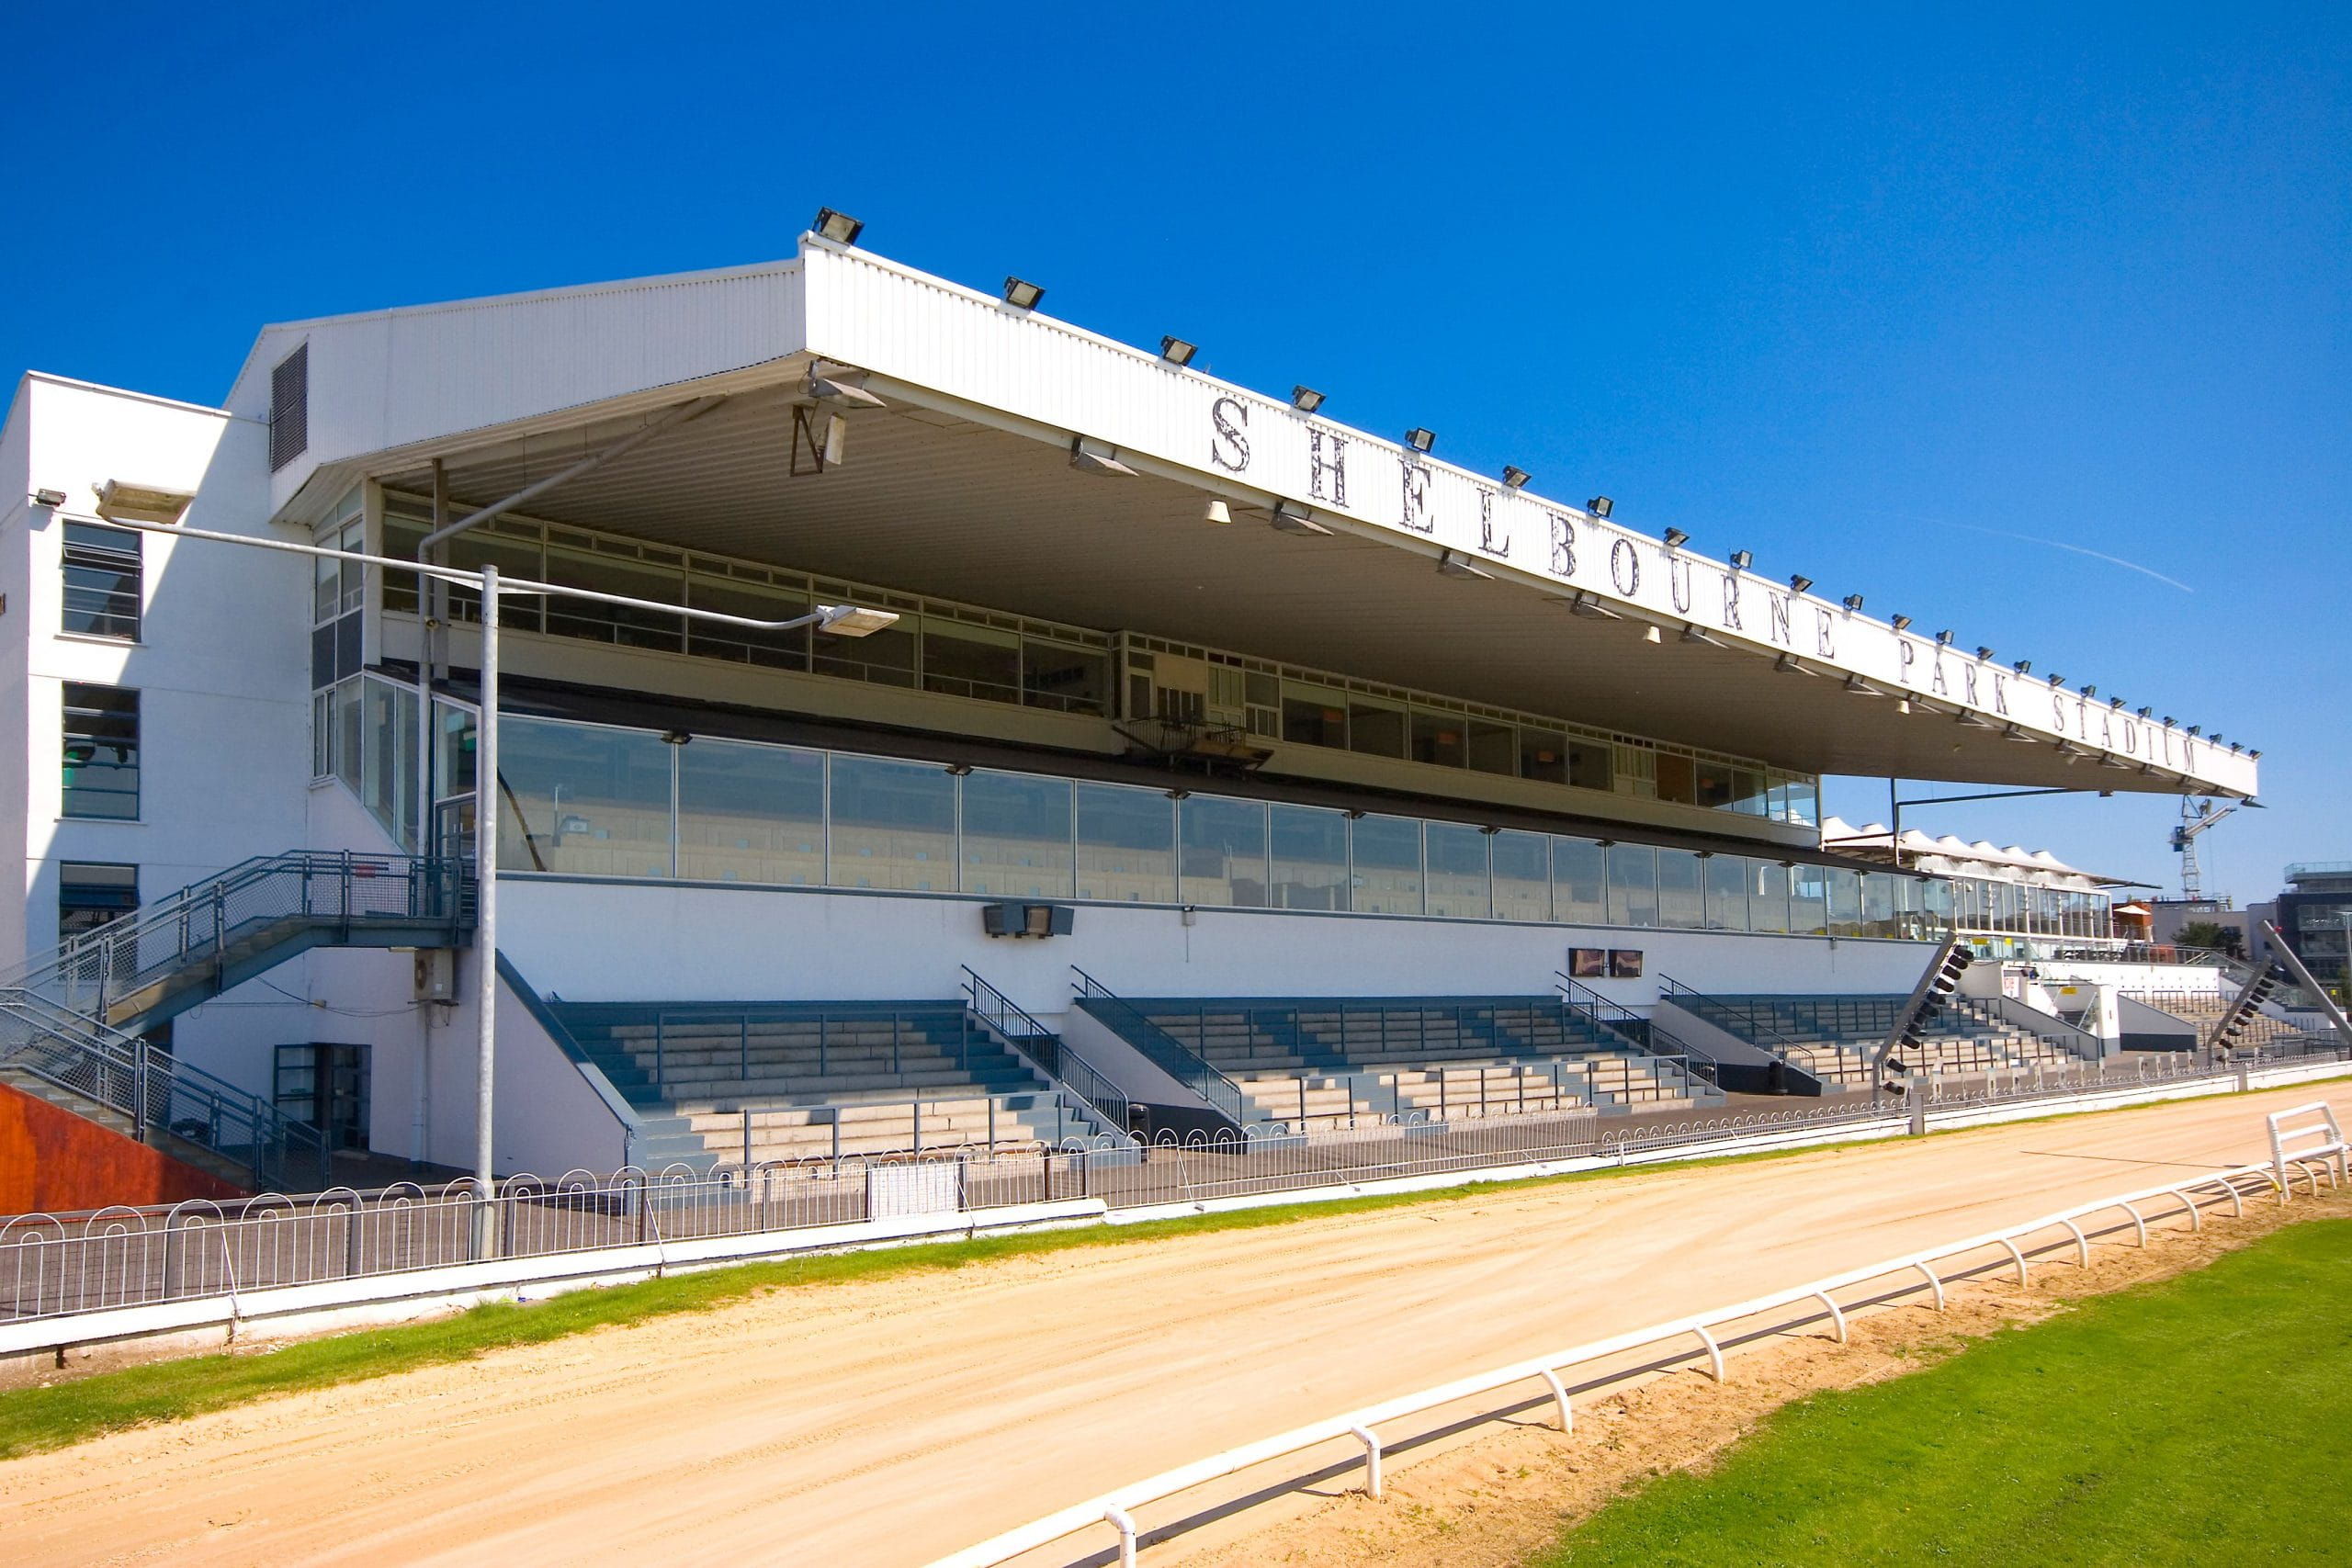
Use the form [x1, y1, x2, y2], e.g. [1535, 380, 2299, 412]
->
[499, 715, 675, 877]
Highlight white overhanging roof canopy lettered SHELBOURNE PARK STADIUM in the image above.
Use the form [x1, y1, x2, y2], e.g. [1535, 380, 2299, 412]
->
[254, 237, 2256, 795]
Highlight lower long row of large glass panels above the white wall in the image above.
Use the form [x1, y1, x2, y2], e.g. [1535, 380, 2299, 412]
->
[499, 717, 1950, 938]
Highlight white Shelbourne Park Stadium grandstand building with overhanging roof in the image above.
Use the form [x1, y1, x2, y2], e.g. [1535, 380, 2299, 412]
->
[0, 214, 2258, 1185]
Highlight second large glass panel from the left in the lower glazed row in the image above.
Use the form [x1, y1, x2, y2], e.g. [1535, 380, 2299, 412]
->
[677, 740, 826, 886]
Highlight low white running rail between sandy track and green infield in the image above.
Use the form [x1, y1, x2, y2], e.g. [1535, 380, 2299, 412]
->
[929, 1166, 2277, 1568]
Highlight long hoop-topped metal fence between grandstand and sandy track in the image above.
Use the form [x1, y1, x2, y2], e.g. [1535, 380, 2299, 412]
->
[0, 1048, 2345, 1321]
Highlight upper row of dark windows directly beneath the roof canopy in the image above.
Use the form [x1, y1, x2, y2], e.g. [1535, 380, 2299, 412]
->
[380, 496, 1820, 825]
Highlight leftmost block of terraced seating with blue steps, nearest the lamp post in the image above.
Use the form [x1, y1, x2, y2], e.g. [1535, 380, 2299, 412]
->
[553, 1001, 1103, 1164]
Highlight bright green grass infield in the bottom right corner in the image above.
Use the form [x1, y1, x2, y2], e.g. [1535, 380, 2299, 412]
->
[1532, 1220, 2352, 1568]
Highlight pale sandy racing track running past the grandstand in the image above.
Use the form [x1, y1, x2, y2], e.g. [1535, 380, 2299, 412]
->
[0, 1089, 2314, 1568]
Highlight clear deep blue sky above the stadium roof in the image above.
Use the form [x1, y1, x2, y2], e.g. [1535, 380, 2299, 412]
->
[0, 5, 2352, 900]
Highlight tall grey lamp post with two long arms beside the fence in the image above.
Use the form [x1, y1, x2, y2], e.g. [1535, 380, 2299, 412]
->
[75, 517, 899, 1258]
